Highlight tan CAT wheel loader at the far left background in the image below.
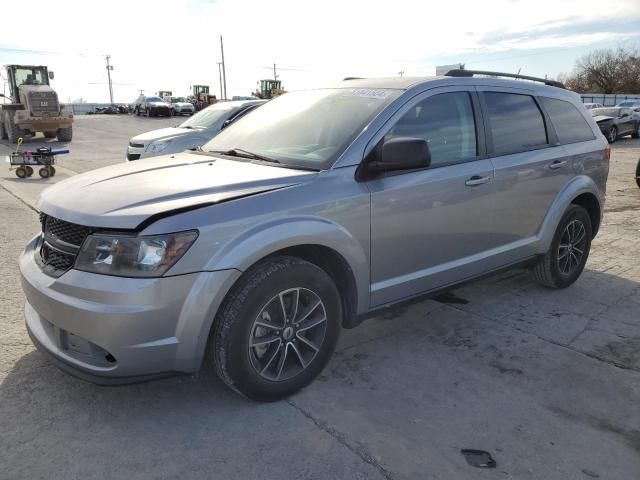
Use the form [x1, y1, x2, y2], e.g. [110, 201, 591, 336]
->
[0, 65, 73, 143]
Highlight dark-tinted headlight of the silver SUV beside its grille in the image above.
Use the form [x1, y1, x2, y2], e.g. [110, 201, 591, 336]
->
[75, 231, 198, 277]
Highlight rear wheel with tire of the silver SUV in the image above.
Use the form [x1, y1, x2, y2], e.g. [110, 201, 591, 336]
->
[532, 204, 593, 288]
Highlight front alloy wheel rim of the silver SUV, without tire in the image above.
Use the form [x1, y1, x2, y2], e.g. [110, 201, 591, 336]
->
[249, 287, 327, 382]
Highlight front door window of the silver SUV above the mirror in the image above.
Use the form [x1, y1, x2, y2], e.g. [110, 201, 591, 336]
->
[384, 92, 477, 165]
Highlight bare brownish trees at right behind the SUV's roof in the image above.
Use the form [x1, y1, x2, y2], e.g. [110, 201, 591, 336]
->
[560, 48, 640, 93]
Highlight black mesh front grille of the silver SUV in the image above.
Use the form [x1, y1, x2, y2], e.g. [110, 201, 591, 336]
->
[40, 213, 93, 277]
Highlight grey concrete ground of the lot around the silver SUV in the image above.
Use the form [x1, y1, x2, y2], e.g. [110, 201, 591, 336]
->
[0, 117, 640, 480]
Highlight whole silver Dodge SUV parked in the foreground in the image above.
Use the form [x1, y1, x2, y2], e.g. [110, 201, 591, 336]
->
[20, 71, 609, 400]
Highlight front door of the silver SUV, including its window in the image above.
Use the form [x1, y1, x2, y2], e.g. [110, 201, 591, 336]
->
[367, 87, 495, 306]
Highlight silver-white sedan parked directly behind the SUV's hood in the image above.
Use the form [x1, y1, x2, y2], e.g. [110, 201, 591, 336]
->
[127, 100, 266, 161]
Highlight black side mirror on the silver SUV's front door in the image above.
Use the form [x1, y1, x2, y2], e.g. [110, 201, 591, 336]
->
[367, 137, 431, 173]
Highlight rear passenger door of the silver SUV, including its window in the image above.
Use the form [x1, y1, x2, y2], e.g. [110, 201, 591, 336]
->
[478, 87, 571, 253]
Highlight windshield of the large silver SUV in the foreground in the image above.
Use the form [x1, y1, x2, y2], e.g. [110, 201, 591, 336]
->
[202, 88, 402, 169]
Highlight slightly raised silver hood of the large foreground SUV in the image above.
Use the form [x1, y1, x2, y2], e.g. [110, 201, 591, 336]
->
[36, 152, 317, 229]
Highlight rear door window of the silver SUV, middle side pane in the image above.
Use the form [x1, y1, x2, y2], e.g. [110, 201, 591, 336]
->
[484, 92, 548, 155]
